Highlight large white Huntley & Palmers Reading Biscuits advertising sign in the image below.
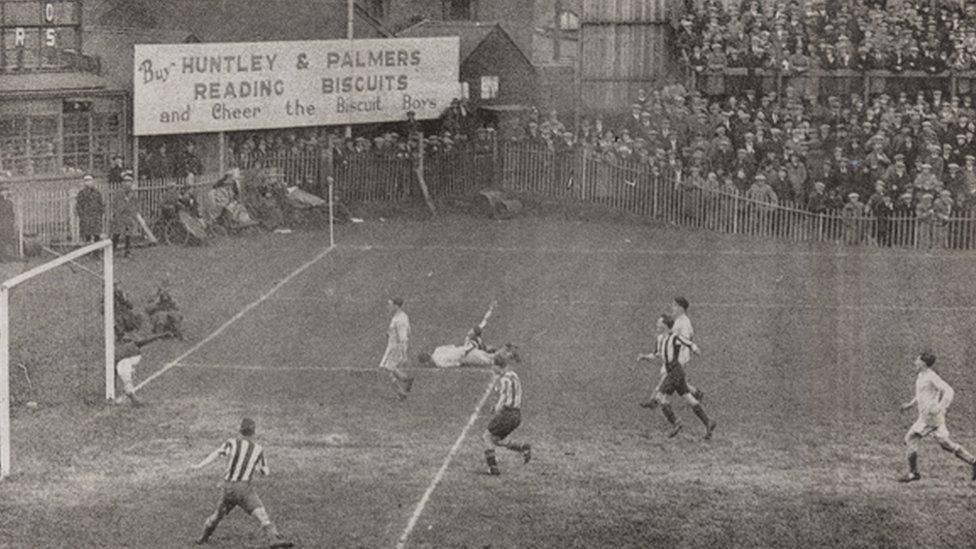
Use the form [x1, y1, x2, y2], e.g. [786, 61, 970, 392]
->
[133, 37, 461, 135]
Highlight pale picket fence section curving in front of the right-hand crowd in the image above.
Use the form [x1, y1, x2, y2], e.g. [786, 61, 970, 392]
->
[500, 143, 976, 250]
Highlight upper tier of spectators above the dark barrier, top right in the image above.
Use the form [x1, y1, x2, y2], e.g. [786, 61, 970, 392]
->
[676, 0, 976, 74]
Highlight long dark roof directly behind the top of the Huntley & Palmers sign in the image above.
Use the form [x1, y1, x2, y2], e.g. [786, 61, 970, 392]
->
[95, 0, 384, 42]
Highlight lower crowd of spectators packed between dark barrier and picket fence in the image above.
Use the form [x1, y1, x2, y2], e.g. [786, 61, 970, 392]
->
[503, 85, 976, 216]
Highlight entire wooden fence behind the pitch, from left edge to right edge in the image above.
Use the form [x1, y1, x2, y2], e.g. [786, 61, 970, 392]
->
[13, 143, 976, 250]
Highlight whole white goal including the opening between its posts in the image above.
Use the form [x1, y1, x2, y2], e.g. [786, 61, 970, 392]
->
[0, 240, 115, 479]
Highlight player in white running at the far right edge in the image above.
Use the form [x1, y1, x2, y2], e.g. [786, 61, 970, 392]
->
[900, 352, 976, 482]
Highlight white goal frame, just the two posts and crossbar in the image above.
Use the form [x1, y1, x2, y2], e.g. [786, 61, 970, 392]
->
[0, 240, 115, 479]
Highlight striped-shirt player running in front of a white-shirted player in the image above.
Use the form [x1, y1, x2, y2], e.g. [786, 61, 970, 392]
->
[637, 315, 717, 440]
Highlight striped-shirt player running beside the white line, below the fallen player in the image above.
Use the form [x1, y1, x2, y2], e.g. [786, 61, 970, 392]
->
[481, 356, 532, 475]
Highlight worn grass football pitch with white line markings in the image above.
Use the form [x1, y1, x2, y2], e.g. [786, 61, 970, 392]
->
[0, 207, 976, 547]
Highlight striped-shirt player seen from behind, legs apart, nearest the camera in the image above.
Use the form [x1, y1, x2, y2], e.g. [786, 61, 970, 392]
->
[193, 417, 293, 547]
